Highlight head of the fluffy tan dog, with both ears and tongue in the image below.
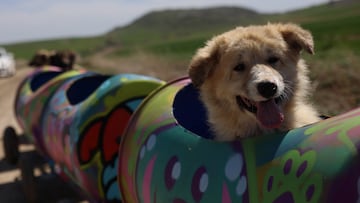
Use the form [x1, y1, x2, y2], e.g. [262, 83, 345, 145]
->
[189, 24, 314, 128]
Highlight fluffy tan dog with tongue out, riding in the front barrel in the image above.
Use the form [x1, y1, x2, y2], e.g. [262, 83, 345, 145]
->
[188, 23, 320, 141]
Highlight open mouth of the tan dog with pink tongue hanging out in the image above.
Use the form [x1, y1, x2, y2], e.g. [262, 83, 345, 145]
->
[236, 96, 284, 128]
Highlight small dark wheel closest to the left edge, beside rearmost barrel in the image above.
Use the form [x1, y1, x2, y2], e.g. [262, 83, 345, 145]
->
[3, 126, 20, 165]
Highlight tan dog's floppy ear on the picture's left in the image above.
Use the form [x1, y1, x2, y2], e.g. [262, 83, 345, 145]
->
[188, 38, 222, 87]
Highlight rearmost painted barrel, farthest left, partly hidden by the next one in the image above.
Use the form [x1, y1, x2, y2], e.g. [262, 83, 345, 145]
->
[15, 66, 89, 158]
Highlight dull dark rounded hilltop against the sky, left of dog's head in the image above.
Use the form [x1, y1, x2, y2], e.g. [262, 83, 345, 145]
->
[106, 7, 262, 44]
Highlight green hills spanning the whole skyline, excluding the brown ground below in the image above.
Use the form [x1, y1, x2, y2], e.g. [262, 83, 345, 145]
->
[5, 1, 360, 59]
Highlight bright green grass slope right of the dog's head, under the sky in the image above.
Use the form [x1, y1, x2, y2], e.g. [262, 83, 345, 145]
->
[267, 1, 360, 56]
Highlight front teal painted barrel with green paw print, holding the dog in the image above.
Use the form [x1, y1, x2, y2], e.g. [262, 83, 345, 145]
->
[118, 78, 360, 203]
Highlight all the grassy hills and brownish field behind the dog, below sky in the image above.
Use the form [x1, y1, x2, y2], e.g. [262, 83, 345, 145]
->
[5, 1, 360, 115]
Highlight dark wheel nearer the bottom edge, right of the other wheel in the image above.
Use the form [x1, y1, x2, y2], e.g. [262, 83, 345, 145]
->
[19, 155, 37, 203]
